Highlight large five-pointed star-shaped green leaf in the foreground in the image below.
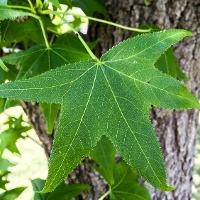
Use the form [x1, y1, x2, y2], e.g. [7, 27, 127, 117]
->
[0, 30, 200, 192]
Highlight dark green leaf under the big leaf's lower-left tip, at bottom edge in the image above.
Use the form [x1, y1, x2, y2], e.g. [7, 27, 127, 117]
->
[32, 179, 90, 200]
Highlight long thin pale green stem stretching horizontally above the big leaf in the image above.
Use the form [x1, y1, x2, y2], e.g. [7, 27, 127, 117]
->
[40, 10, 151, 33]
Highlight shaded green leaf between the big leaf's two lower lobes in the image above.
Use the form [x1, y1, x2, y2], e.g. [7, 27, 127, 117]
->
[91, 136, 150, 200]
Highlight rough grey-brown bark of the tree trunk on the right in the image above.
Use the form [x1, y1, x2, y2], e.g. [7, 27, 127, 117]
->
[90, 0, 200, 200]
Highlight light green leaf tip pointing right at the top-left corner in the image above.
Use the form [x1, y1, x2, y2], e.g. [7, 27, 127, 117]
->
[0, 5, 31, 20]
